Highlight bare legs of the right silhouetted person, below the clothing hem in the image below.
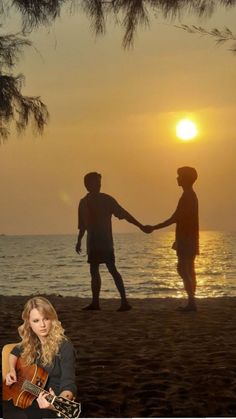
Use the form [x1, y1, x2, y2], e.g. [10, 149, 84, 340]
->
[177, 256, 196, 310]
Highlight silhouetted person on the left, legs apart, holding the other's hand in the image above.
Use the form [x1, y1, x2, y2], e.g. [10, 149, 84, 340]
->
[76, 172, 143, 311]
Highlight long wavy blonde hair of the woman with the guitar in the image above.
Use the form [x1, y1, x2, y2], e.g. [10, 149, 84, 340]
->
[18, 297, 66, 365]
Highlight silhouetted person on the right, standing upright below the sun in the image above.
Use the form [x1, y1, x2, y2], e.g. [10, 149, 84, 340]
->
[144, 166, 199, 311]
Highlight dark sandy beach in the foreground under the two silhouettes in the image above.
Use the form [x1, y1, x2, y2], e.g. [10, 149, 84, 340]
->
[0, 295, 236, 417]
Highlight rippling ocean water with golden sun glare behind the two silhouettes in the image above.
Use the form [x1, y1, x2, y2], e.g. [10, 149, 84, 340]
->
[0, 231, 236, 298]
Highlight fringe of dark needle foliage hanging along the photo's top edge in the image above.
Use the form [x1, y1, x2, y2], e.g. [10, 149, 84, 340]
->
[7, 0, 236, 48]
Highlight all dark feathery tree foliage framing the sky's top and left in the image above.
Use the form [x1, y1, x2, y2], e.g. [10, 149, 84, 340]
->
[0, 0, 236, 141]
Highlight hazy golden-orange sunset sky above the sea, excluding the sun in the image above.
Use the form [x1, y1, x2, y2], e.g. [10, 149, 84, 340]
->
[0, 3, 236, 234]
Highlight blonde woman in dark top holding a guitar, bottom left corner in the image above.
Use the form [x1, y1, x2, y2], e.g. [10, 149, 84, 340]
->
[3, 297, 76, 419]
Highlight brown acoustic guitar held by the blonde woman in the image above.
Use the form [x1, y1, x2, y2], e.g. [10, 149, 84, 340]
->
[3, 358, 81, 418]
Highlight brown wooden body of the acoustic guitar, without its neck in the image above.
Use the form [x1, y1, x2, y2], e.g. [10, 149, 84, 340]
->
[3, 358, 48, 409]
